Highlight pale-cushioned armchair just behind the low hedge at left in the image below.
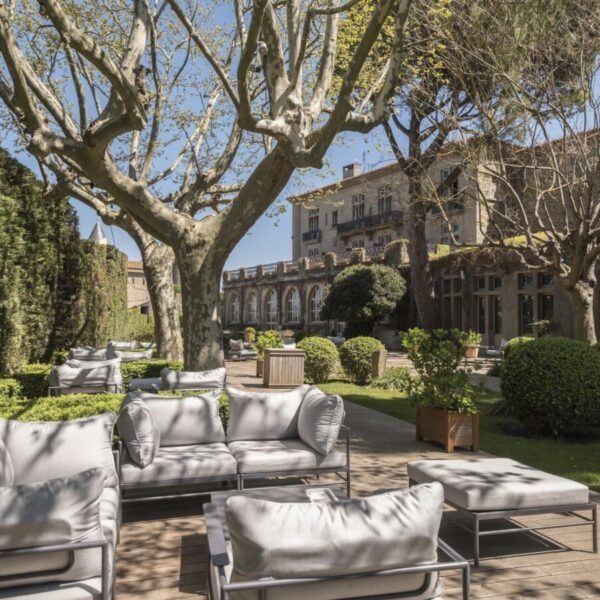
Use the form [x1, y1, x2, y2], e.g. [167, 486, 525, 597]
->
[48, 358, 123, 395]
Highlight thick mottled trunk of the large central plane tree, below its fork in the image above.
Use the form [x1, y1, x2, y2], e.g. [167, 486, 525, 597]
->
[177, 248, 225, 371]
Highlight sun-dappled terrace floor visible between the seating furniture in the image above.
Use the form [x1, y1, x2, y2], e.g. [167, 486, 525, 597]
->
[117, 362, 600, 600]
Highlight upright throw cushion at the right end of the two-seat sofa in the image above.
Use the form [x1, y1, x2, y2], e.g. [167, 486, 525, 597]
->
[298, 387, 344, 454]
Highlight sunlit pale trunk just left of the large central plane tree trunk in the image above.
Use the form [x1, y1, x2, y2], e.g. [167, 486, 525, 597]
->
[140, 242, 183, 360]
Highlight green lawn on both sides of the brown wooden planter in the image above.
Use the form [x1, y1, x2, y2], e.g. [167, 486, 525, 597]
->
[319, 381, 600, 491]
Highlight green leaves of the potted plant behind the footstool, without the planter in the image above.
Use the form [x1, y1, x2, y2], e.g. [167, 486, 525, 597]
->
[402, 328, 476, 414]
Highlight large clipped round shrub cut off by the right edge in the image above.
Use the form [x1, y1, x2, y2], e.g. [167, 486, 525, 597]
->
[501, 337, 600, 436]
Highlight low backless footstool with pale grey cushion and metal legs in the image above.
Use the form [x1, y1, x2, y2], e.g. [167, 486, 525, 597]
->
[407, 458, 598, 566]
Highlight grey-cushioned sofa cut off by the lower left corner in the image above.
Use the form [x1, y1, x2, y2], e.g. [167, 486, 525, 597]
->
[0, 413, 120, 600]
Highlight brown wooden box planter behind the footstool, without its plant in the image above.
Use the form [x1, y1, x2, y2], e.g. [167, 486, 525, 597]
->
[417, 406, 479, 452]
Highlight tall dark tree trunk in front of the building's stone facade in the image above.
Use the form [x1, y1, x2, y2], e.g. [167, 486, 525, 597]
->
[408, 177, 435, 329]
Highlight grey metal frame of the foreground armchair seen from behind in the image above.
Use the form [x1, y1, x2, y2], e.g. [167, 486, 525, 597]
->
[204, 504, 470, 600]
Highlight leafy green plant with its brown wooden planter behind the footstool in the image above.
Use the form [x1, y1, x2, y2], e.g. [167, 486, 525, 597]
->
[402, 328, 479, 452]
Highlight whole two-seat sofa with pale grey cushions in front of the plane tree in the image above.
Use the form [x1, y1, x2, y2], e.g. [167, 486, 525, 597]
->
[117, 385, 350, 501]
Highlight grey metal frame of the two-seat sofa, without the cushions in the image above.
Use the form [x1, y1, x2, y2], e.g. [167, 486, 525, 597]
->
[118, 425, 352, 503]
